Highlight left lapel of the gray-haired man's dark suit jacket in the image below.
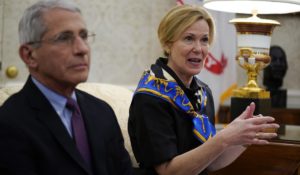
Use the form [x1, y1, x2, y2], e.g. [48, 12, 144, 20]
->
[23, 78, 91, 174]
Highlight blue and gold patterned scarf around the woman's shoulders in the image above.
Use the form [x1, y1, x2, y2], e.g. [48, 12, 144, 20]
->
[135, 70, 216, 143]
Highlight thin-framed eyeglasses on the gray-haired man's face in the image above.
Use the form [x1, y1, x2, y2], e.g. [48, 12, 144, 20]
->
[27, 32, 96, 46]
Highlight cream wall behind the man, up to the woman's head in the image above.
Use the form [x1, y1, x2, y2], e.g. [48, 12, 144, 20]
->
[0, 0, 176, 86]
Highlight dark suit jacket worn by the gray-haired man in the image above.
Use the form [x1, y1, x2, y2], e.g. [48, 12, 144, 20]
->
[0, 78, 132, 175]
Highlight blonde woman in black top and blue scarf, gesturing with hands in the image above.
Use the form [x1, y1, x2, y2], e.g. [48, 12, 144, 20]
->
[128, 5, 279, 175]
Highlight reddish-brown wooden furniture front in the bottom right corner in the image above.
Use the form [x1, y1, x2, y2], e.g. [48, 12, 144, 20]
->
[210, 141, 300, 175]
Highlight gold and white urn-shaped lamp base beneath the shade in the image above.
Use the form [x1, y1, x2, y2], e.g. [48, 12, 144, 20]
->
[230, 14, 279, 99]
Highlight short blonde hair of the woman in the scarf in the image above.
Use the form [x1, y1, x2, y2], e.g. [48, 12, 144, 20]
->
[157, 5, 215, 56]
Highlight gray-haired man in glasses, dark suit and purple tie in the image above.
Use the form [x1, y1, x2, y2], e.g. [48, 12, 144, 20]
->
[0, 0, 132, 175]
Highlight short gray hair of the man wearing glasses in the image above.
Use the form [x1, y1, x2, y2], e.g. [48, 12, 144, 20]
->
[19, 0, 81, 47]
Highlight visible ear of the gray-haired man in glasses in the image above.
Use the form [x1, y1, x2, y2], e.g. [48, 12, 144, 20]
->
[19, 44, 37, 68]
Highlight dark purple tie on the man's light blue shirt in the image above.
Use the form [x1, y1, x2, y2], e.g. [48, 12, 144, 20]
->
[66, 98, 91, 166]
